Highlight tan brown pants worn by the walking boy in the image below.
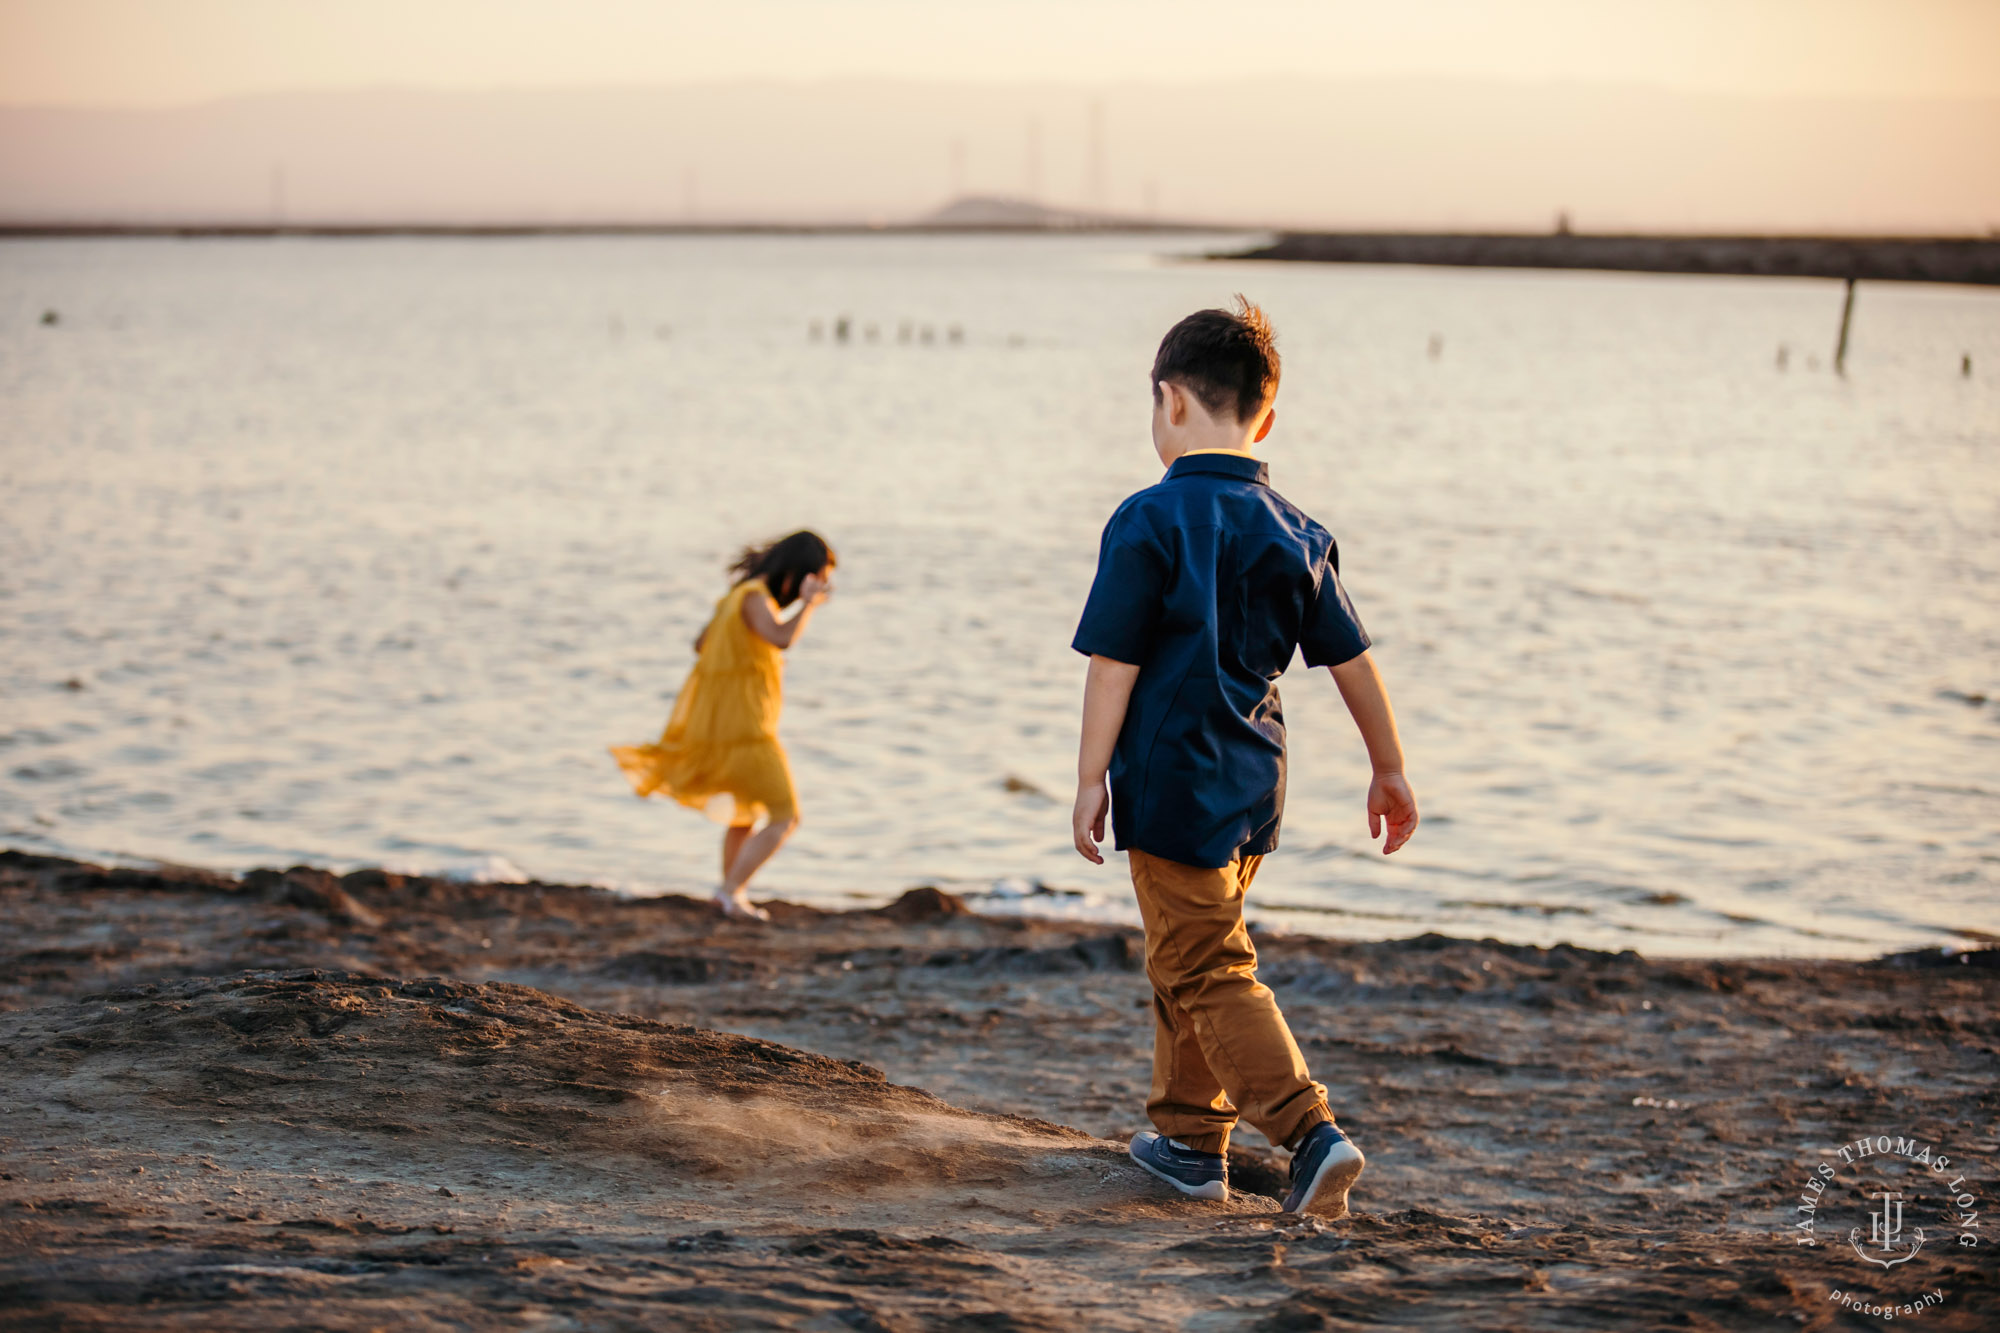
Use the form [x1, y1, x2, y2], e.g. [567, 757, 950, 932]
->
[1130, 851, 1334, 1153]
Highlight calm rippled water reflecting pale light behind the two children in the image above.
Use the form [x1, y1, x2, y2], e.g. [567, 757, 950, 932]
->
[0, 238, 2000, 955]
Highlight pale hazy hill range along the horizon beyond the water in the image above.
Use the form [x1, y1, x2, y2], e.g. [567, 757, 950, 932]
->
[0, 78, 2000, 234]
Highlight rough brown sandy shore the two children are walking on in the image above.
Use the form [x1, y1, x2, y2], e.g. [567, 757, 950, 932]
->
[0, 853, 2000, 1329]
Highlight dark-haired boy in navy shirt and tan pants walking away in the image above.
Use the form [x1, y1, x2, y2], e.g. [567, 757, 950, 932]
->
[1072, 296, 1416, 1217]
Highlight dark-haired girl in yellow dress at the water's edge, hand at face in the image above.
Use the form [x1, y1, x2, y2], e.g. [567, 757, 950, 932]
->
[612, 532, 834, 921]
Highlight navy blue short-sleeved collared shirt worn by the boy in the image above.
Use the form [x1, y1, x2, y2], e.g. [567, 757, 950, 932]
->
[1072, 454, 1368, 869]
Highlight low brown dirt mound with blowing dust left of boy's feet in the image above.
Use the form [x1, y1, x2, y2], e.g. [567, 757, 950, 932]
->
[0, 971, 1112, 1195]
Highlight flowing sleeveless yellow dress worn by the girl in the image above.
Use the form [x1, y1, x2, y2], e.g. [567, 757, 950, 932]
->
[612, 578, 798, 825]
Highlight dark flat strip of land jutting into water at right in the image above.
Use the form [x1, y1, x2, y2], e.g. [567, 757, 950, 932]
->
[1210, 232, 2000, 286]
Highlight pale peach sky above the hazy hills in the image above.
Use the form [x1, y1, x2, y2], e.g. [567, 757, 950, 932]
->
[0, 0, 2000, 106]
